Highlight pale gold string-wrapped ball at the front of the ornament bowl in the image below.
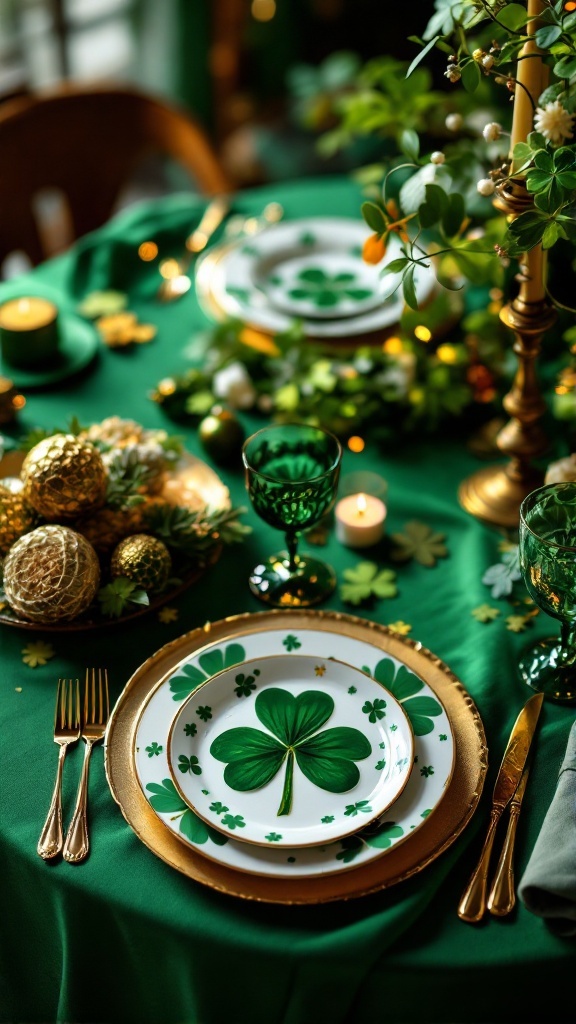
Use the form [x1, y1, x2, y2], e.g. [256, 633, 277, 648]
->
[4, 525, 100, 625]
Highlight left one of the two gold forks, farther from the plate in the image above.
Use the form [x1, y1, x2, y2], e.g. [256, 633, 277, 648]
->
[36, 679, 80, 860]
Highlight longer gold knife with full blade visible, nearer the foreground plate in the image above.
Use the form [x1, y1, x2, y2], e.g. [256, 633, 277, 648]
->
[458, 693, 544, 923]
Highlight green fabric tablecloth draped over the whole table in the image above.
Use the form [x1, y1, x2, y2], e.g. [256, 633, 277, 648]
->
[0, 179, 574, 1024]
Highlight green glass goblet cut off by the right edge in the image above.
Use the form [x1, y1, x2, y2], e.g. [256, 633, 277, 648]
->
[520, 481, 576, 703]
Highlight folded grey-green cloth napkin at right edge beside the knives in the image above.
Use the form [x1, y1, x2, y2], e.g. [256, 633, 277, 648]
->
[519, 721, 576, 936]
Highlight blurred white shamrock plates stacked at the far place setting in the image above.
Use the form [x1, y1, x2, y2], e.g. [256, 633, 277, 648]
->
[196, 217, 435, 339]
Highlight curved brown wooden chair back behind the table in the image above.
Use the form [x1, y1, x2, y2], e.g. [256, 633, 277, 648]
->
[0, 86, 233, 264]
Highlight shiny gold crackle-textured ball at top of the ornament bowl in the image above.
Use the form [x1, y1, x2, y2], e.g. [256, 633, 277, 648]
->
[20, 434, 108, 521]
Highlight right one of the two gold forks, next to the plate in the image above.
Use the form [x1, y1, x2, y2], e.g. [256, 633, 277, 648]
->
[63, 669, 110, 864]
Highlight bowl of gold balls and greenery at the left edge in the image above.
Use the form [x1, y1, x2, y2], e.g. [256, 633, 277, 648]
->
[0, 417, 243, 630]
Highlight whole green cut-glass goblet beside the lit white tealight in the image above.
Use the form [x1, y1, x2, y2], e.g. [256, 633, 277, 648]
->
[242, 423, 342, 608]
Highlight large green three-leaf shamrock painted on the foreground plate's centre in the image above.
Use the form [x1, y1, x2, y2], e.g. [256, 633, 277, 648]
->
[210, 687, 372, 816]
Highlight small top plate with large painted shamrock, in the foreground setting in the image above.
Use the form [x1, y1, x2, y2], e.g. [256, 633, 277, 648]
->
[168, 654, 414, 848]
